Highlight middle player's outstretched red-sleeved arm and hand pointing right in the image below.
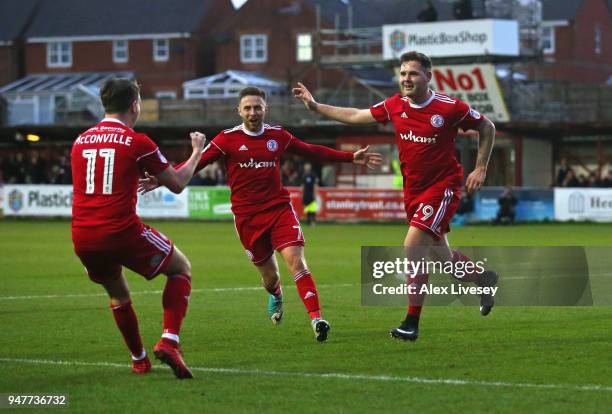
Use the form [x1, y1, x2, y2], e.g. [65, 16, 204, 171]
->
[287, 137, 382, 169]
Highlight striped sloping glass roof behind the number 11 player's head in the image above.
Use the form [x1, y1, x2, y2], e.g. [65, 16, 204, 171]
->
[0, 72, 135, 94]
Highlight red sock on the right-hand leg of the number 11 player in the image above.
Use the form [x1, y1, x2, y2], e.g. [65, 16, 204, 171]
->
[162, 275, 191, 342]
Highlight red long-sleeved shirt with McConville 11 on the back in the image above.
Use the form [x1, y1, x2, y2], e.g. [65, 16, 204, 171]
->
[72, 118, 169, 247]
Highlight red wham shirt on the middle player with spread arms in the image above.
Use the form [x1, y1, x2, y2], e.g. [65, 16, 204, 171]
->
[191, 124, 353, 215]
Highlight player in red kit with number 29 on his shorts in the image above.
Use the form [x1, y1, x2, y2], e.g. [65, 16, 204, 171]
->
[293, 52, 497, 341]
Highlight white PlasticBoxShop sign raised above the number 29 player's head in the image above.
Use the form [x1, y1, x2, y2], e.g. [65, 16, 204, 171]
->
[383, 19, 519, 60]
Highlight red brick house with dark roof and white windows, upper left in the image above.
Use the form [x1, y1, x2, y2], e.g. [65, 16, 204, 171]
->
[19, 0, 232, 98]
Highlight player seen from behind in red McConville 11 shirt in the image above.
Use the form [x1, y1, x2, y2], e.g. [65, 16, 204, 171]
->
[72, 78, 206, 378]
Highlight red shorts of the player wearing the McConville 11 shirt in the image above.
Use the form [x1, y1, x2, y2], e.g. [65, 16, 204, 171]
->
[74, 224, 174, 283]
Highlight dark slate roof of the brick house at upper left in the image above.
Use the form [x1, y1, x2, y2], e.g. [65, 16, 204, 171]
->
[25, 0, 213, 38]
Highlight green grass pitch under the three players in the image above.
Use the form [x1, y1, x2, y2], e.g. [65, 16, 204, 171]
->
[0, 220, 612, 414]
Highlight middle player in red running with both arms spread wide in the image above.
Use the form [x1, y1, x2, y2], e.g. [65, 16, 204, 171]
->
[141, 87, 382, 342]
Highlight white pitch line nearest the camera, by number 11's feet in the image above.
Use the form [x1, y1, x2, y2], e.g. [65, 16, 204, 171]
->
[0, 358, 612, 392]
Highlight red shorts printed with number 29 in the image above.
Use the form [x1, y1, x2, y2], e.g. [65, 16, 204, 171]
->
[405, 182, 461, 240]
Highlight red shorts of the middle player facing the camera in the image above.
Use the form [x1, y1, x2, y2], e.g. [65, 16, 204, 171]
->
[234, 203, 304, 264]
